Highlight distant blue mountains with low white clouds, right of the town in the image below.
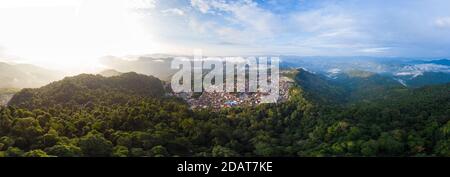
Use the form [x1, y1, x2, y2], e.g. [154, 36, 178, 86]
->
[281, 56, 450, 88]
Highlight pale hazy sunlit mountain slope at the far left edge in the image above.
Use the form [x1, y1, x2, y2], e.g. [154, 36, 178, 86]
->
[0, 62, 63, 88]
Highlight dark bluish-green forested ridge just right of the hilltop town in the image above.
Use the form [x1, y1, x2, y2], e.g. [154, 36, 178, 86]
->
[295, 69, 406, 104]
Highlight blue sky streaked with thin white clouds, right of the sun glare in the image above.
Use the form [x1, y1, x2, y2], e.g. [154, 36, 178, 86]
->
[130, 0, 450, 56]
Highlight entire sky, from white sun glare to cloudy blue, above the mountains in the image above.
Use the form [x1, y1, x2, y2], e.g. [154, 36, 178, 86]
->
[0, 0, 450, 70]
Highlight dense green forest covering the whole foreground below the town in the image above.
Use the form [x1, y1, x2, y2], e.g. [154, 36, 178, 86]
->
[0, 73, 450, 157]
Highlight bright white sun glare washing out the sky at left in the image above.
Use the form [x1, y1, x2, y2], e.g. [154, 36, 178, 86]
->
[0, 0, 158, 73]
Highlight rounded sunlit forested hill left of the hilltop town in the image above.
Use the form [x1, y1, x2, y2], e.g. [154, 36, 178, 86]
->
[8, 73, 165, 108]
